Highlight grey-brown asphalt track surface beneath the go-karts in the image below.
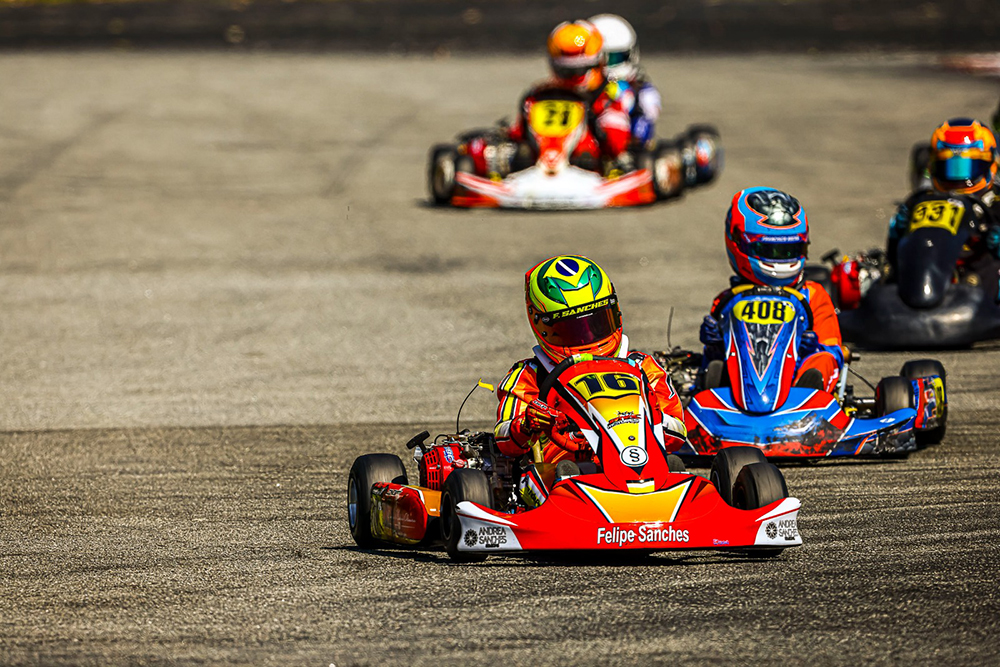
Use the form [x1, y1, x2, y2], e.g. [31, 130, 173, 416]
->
[0, 53, 1000, 666]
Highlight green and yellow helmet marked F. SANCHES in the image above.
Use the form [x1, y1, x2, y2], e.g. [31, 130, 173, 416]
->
[524, 255, 622, 361]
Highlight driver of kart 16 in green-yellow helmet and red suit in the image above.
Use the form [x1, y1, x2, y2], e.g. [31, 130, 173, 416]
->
[494, 255, 687, 470]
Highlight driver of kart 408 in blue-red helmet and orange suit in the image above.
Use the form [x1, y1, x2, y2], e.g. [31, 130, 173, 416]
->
[699, 187, 844, 393]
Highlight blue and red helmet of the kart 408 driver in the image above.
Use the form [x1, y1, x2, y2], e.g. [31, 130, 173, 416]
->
[726, 187, 809, 287]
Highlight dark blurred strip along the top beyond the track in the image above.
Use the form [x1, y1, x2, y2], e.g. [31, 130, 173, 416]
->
[0, 0, 1000, 55]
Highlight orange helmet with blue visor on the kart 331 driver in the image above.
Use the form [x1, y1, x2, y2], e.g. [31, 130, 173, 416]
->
[930, 118, 1000, 194]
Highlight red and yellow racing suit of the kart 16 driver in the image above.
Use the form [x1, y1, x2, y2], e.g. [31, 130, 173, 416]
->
[493, 337, 687, 463]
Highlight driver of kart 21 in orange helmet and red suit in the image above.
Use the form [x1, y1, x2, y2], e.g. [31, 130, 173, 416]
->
[508, 21, 635, 176]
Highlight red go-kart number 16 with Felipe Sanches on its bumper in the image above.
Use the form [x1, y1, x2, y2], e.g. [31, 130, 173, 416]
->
[348, 355, 802, 561]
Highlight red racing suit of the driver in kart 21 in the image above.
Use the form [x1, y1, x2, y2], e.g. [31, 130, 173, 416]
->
[508, 79, 635, 164]
